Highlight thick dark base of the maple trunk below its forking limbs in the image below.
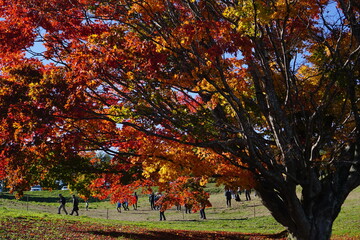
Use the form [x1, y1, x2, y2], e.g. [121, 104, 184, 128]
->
[257, 180, 345, 240]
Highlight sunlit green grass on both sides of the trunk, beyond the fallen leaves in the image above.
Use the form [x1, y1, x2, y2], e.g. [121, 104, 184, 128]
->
[0, 186, 360, 239]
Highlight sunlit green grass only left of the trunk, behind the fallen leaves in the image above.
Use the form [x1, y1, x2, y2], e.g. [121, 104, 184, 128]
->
[0, 188, 284, 233]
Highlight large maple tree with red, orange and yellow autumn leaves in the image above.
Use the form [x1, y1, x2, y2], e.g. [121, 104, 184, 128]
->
[0, 0, 360, 239]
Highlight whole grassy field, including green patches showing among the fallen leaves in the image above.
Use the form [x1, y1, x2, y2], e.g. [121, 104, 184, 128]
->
[0, 186, 360, 239]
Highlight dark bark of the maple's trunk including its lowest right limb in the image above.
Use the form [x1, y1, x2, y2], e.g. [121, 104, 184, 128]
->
[256, 148, 360, 240]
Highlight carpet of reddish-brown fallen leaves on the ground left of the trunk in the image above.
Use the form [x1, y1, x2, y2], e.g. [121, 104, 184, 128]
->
[0, 217, 283, 240]
